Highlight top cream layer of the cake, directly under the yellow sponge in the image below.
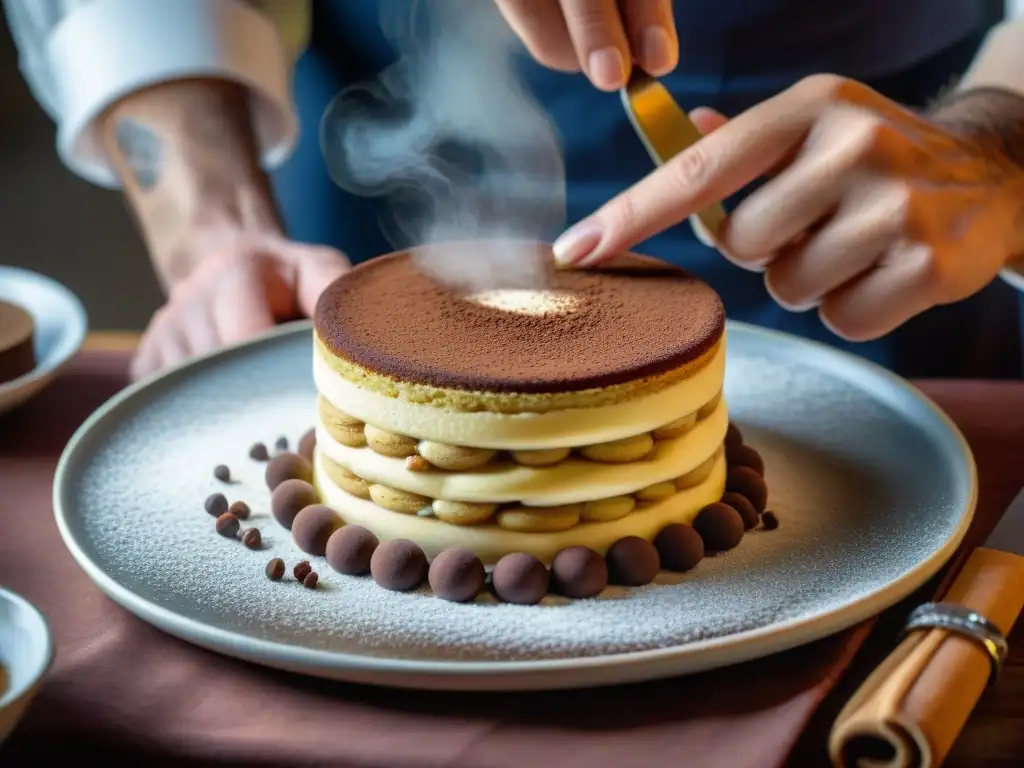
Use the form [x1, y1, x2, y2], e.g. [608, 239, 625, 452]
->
[313, 335, 725, 450]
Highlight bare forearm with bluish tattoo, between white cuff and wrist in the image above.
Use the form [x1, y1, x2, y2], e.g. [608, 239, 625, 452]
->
[104, 80, 283, 288]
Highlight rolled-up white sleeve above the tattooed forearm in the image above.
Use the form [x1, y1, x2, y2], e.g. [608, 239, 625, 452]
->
[3, 0, 309, 188]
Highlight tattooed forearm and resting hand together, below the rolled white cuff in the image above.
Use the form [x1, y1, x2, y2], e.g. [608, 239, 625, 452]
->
[101, 78, 348, 385]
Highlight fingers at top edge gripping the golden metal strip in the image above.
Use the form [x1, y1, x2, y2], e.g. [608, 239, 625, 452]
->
[495, 0, 679, 91]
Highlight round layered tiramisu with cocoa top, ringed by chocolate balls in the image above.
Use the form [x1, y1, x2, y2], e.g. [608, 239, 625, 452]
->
[274, 250, 766, 603]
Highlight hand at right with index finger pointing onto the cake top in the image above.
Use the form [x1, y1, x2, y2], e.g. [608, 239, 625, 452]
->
[555, 75, 1024, 340]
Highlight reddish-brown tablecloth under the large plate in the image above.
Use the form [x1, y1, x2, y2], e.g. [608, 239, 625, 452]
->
[0, 352, 1024, 768]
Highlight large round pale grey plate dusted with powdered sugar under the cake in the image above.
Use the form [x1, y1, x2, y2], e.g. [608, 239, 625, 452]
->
[54, 324, 976, 689]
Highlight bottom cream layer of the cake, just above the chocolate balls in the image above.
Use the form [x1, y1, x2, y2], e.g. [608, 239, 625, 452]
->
[314, 446, 725, 565]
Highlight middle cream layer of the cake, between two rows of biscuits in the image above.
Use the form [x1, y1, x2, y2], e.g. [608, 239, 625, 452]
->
[316, 401, 729, 507]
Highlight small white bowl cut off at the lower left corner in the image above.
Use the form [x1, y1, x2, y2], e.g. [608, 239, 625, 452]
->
[0, 589, 53, 743]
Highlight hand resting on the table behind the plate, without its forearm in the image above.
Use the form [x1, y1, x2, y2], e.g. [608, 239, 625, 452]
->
[131, 236, 348, 378]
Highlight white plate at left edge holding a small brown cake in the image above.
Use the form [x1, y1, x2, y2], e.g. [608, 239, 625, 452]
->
[0, 266, 89, 414]
